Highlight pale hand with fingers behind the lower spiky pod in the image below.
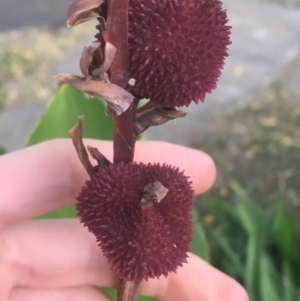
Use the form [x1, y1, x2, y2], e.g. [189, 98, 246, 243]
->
[0, 139, 248, 301]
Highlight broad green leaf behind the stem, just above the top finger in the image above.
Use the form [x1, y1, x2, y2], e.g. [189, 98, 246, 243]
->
[27, 84, 113, 145]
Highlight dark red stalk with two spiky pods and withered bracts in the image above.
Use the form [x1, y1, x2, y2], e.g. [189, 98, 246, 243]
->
[58, 0, 230, 301]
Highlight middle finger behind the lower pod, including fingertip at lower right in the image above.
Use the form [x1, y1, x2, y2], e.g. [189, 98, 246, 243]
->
[3, 219, 248, 301]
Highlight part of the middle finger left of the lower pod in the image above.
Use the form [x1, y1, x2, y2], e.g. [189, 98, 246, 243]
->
[1, 219, 117, 289]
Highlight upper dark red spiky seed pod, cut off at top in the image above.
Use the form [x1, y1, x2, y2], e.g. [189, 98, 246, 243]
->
[128, 0, 231, 106]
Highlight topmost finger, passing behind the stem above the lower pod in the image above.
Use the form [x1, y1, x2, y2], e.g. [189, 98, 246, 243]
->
[0, 139, 216, 227]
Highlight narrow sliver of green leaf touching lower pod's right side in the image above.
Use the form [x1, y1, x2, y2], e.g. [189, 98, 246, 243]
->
[190, 210, 210, 262]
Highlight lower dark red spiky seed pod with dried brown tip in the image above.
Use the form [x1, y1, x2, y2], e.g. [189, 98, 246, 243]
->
[76, 162, 193, 281]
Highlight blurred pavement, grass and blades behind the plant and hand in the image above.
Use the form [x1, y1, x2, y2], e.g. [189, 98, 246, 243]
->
[0, 0, 300, 301]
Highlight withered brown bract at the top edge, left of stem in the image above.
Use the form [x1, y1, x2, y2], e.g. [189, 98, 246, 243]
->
[67, 0, 104, 27]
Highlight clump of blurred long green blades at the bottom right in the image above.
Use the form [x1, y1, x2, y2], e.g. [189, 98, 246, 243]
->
[198, 182, 300, 301]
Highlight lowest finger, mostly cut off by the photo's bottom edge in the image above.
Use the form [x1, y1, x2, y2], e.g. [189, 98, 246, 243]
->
[7, 286, 111, 301]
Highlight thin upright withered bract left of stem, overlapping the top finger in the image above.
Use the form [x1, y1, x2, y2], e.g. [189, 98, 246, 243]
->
[69, 116, 95, 177]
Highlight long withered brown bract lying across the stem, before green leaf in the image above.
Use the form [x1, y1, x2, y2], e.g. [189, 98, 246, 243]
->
[56, 74, 134, 116]
